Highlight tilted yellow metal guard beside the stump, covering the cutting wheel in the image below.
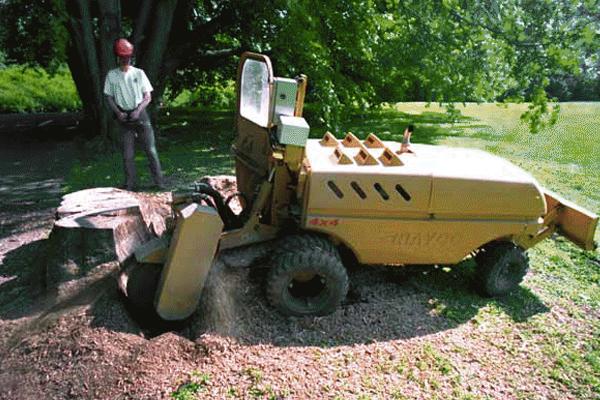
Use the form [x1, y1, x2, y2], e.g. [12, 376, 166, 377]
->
[155, 203, 223, 320]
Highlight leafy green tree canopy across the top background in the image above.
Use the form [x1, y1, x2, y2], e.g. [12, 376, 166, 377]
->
[0, 0, 600, 131]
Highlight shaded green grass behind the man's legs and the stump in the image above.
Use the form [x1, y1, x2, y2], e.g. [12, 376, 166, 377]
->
[65, 108, 235, 192]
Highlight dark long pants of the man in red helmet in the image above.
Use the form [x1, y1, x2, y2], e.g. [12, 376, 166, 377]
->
[119, 110, 163, 189]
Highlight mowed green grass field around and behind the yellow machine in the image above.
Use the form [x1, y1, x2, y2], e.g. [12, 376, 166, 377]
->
[67, 103, 600, 399]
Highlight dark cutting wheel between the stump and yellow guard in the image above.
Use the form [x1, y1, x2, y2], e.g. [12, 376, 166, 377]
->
[126, 264, 163, 318]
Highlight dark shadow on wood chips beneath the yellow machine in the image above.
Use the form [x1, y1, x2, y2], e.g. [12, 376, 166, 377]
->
[157, 253, 548, 347]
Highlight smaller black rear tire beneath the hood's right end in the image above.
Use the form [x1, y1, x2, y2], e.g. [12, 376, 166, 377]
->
[475, 242, 529, 297]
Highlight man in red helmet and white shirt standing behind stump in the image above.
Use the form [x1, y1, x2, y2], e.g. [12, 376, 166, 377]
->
[104, 39, 164, 190]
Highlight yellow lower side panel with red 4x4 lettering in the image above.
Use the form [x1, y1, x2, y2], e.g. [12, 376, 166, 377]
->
[305, 214, 541, 264]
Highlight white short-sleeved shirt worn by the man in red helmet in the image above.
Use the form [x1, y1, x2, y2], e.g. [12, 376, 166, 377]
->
[104, 66, 154, 111]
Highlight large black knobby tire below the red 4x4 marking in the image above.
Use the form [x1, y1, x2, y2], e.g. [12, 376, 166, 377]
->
[266, 235, 348, 316]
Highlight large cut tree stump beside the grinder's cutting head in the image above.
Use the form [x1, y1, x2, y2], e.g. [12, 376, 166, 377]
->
[44, 188, 172, 294]
